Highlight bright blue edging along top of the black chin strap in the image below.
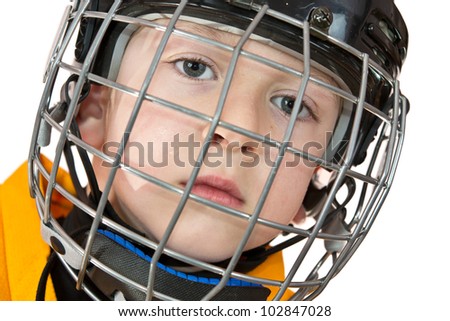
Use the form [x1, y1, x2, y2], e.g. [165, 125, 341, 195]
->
[98, 230, 261, 287]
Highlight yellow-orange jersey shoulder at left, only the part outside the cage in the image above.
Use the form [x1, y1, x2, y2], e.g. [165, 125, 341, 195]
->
[0, 159, 55, 301]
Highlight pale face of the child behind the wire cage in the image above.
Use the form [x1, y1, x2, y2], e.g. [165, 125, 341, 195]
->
[81, 22, 340, 262]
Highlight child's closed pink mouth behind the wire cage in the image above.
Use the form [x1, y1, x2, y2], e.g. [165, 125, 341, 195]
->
[182, 175, 244, 209]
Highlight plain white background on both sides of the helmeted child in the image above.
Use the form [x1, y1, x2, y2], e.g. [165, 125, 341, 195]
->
[0, 0, 450, 320]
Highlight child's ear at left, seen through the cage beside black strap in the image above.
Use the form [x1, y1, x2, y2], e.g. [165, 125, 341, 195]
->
[77, 84, 110, 149]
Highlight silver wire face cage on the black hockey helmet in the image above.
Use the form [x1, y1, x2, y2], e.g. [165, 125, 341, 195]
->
[29, 0, 408, 300]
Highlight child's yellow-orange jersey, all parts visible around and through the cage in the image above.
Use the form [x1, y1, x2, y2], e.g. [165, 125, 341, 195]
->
[0, 159, 288, 301]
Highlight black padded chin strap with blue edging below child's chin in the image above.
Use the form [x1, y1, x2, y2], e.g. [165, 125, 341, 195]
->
[87, 230, 270, 301]
